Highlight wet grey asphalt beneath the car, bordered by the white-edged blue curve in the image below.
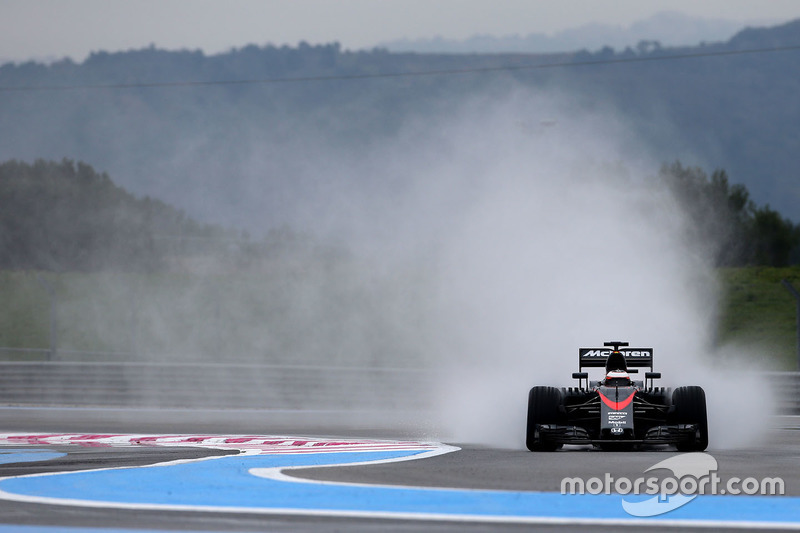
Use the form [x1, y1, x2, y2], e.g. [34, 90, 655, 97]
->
[292, 430, 800, 494]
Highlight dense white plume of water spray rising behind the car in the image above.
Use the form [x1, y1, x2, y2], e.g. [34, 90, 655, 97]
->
[310, 94, 765, 448]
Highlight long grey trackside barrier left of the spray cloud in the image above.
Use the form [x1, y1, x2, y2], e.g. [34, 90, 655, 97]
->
[0, 361, 432, 410]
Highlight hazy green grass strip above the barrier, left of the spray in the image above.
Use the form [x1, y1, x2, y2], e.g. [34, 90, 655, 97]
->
[0, 264, 432, 365]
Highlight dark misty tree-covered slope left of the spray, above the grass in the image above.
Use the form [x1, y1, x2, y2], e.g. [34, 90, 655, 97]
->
[0, 159, 238, 271]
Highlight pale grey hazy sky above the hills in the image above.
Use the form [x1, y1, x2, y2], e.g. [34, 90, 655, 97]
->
[0, 0, 800, 61]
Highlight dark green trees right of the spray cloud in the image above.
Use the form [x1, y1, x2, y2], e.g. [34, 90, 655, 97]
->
[660, 162, 800, 267]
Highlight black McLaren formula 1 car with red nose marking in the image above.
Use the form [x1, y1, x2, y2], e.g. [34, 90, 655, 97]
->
[526, 341, 708, 451]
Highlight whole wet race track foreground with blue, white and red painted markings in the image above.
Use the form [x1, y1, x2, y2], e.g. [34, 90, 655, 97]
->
[0, 411, 800, 533]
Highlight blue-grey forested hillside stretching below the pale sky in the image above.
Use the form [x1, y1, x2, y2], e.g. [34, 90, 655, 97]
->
[0, 21, 800, 232]
